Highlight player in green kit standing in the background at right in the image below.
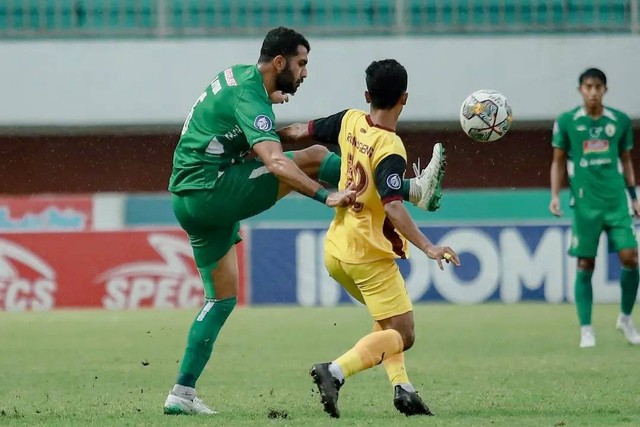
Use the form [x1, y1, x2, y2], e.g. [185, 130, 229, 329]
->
[549, 68, 640, 347]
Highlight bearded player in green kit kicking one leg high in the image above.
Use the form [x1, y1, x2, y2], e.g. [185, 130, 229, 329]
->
[164, 27, 443, 414]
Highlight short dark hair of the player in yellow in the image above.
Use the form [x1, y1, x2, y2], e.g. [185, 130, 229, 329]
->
[366, 59, 408, 110]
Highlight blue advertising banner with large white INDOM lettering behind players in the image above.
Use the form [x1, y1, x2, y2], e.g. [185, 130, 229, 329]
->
[248, 223, 636, 306]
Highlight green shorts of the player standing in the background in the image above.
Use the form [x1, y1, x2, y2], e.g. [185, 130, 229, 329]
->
[569, 203, 638, 258]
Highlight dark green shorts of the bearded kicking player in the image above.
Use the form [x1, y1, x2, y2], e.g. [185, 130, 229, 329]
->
[171, 153, 292, 269]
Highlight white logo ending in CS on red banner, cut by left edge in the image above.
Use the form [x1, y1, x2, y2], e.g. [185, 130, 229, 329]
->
[0, 239, 58, 311]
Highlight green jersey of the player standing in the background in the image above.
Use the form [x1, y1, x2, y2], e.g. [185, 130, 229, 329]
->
[552, 107, 633, 206]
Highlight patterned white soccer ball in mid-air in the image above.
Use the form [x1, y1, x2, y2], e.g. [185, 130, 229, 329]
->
[460, 90, 512, 142]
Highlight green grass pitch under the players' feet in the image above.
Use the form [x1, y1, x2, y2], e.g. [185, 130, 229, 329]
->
[0, 304, 640, 427]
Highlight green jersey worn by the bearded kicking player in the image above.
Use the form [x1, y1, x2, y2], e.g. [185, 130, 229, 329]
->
[169, 65, 280, 193]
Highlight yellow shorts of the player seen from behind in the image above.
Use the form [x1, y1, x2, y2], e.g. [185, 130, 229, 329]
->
[324, 252, 413, 320]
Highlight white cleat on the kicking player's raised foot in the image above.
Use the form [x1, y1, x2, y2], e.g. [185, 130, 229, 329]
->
[410, 142, 447, 212]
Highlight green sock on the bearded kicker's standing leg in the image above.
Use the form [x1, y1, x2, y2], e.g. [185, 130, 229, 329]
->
[176, 297, 236, 388]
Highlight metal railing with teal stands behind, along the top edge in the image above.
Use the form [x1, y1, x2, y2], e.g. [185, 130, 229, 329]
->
[0, 0, 640, 38]
